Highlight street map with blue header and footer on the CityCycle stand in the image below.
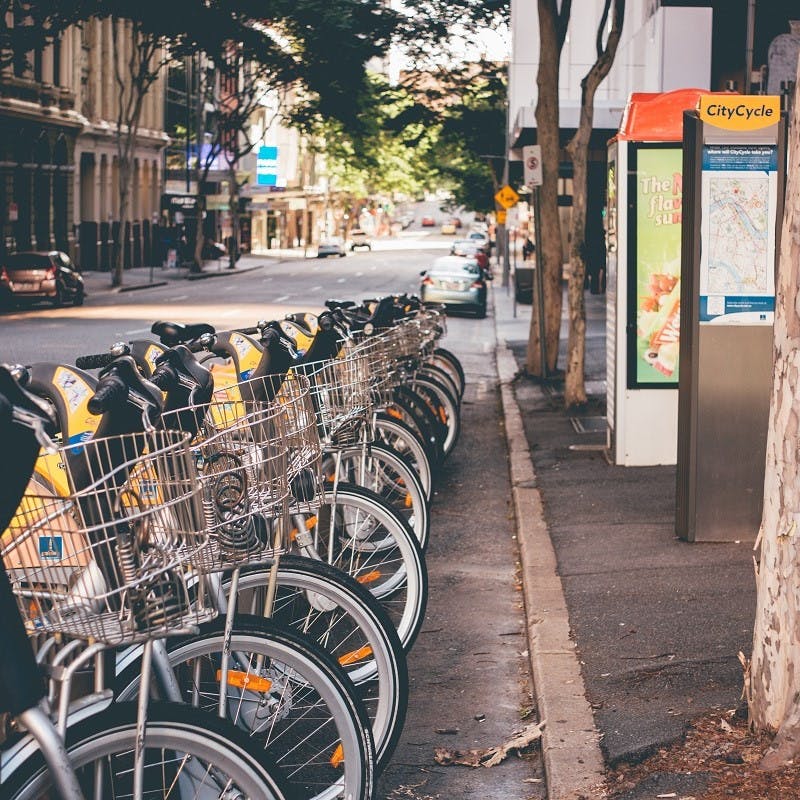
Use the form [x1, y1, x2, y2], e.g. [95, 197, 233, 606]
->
[699, 144, 778, 325]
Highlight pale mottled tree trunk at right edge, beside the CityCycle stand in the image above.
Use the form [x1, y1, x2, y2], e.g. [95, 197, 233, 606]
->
[746, 69, 800, 769]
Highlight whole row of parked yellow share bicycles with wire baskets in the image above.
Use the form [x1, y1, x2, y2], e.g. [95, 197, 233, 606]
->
[0, 296, 464, 800]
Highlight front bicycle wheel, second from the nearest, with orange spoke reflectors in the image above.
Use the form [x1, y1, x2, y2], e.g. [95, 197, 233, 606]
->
[117, 614, 376, 800]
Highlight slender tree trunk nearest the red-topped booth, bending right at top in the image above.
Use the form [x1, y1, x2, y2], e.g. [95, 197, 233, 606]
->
[564, 0, 625, 409]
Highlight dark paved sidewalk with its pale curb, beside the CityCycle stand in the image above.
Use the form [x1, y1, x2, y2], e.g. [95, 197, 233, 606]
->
[494, 281, 755, 800]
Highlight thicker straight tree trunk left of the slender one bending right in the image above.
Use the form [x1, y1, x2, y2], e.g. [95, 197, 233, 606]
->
[526, 0, 563, 378]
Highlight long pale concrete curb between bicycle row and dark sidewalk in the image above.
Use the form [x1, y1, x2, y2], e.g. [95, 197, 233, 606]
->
[495, 290, 606, 800]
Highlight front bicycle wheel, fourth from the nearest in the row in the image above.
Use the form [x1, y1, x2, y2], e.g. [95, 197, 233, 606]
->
[312, 484, 428, 652]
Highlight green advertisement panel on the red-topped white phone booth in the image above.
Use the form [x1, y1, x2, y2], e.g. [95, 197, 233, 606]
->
[628, 150, 683, 388]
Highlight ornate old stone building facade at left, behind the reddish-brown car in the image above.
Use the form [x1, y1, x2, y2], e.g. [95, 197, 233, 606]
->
[0, 18, 167, 269]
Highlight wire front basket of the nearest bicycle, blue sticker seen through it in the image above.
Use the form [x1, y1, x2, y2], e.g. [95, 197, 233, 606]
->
[0, 431, 215, 645]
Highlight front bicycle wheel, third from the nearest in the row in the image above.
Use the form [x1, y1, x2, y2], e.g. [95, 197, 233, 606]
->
[230, 556, 408, 771]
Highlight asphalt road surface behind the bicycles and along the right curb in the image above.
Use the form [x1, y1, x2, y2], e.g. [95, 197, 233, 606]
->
[0, 231, 545, 800]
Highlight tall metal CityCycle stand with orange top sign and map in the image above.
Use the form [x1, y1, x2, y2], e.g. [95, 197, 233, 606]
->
[675, 95, 786, 541]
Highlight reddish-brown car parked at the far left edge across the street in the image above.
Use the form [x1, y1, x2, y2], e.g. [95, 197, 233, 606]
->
[0, 250, 86, 307]
